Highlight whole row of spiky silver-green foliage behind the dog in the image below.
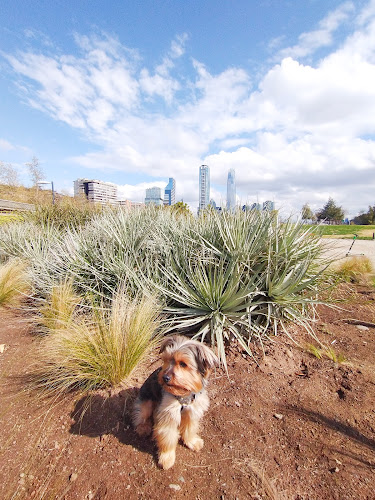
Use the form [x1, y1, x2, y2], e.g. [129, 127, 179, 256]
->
[0, 207, 324, 363]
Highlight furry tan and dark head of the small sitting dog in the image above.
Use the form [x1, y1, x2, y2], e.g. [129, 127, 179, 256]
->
[158, 335, 219, 396]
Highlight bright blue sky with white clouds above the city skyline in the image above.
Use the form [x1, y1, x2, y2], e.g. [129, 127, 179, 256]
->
[0, 0, 375, 218]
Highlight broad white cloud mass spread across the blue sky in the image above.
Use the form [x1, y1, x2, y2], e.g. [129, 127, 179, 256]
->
[2, 2, 375, 214]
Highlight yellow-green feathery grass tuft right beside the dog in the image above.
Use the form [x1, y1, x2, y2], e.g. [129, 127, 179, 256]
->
[32, 289, 160, 395]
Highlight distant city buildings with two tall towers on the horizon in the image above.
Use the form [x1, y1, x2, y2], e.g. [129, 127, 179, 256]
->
[74, 165, 275, 214]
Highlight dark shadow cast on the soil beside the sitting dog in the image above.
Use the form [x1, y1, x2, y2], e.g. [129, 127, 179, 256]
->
[69, 388, 156, 459]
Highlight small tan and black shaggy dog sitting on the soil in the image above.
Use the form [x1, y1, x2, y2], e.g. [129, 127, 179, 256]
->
[133, 335, 219, 469]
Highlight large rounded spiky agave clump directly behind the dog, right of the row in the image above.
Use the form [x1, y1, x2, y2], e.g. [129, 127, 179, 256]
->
[153, 212, 323, 366]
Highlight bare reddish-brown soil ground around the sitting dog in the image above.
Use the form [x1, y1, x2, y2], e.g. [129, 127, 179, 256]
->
[0, 288, 375, 500]
